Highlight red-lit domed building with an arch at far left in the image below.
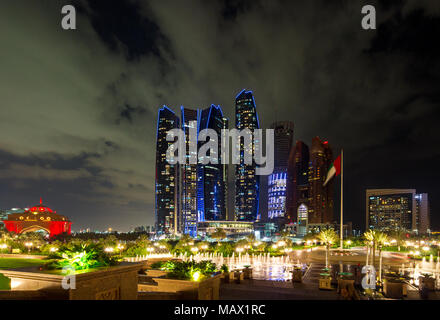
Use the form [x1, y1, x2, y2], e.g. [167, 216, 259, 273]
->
[3, 199, 72, 238]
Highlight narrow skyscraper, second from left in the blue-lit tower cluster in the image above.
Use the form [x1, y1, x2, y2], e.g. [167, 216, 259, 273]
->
[179, 107, 199, 237]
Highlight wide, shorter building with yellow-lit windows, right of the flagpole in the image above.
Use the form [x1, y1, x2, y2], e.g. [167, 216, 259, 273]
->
[366, 189, 420, 232]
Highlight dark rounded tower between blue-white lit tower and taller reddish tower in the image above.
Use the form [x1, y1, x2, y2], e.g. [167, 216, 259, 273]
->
[286, 141, 310, 223]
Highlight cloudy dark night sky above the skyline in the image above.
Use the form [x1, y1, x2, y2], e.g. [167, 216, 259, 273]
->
[0, 0, 440, 231]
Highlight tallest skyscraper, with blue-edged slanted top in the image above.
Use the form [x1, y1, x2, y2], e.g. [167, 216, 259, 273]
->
[235, 90, 260, 221]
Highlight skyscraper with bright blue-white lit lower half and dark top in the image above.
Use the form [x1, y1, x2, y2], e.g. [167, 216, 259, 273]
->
[267, 121, 293, 222]
